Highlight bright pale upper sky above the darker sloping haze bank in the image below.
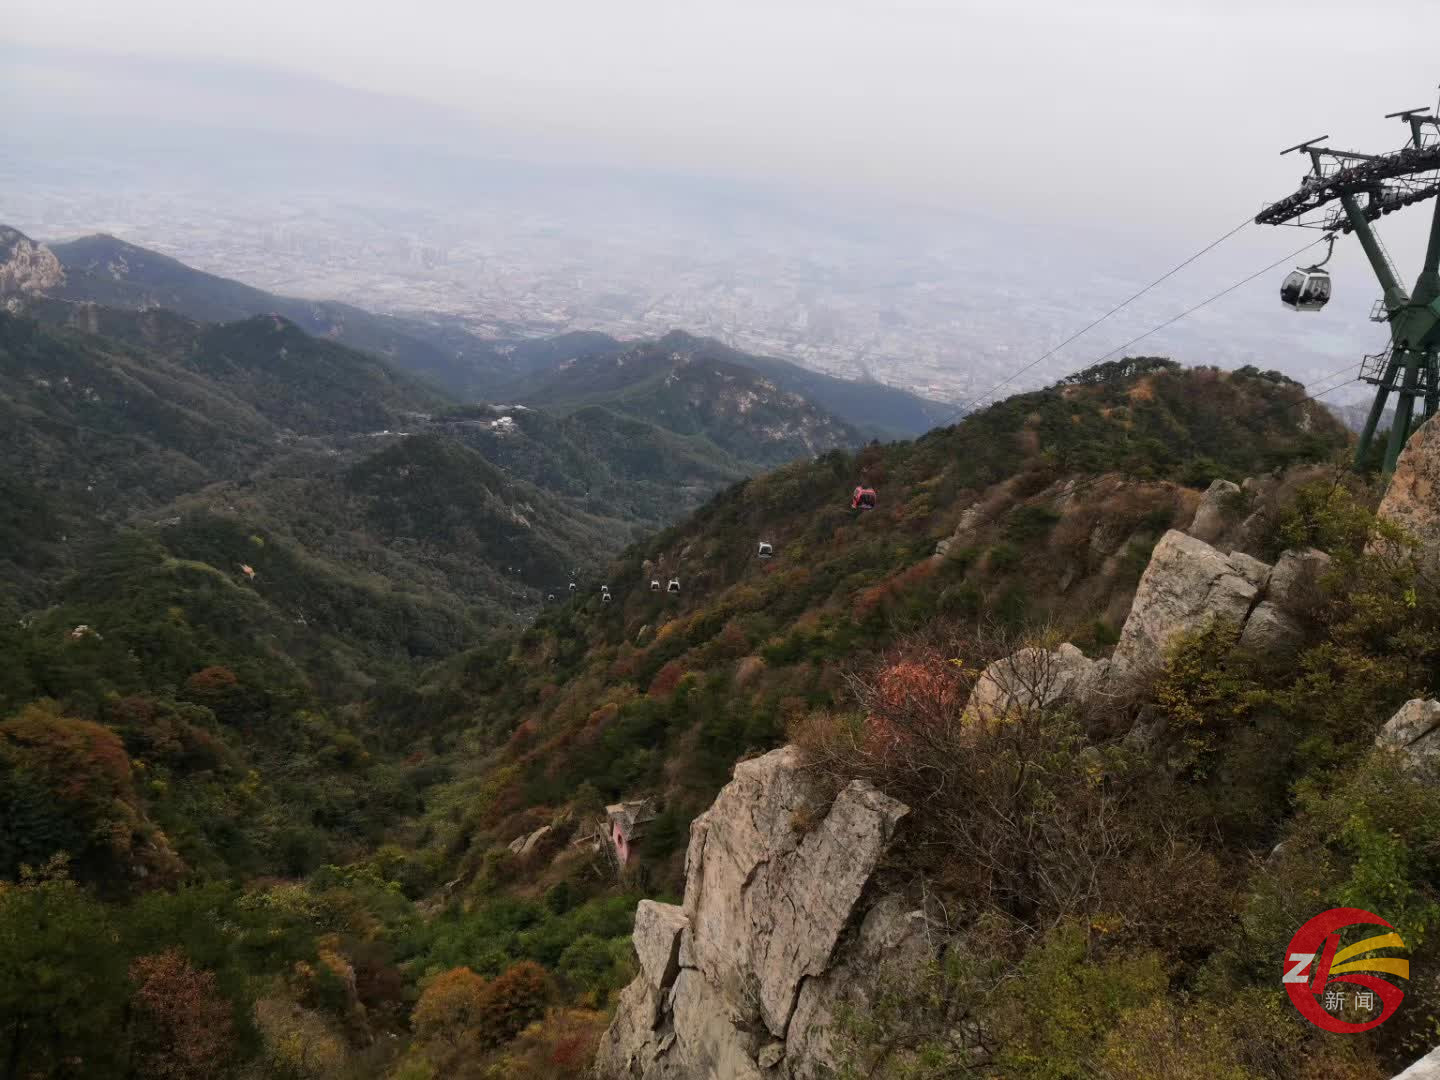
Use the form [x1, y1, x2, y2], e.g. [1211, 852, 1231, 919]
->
[11, 0, 1440, 225]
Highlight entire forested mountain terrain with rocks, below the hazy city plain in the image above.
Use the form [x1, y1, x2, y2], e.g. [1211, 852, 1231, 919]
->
[8, 208, 1440, 1080]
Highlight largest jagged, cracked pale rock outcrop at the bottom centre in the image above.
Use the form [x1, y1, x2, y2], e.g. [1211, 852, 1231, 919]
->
[596, 747, 919, 1080]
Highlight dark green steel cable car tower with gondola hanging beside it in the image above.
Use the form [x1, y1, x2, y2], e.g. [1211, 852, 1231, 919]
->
[1256, 108, 1440, 474]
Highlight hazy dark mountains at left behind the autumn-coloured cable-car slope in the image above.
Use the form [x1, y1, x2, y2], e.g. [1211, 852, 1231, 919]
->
[0, 229, 950, 687]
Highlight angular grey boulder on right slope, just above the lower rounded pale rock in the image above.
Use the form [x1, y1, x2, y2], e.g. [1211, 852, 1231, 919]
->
[1107, 528, 1264, 681]
